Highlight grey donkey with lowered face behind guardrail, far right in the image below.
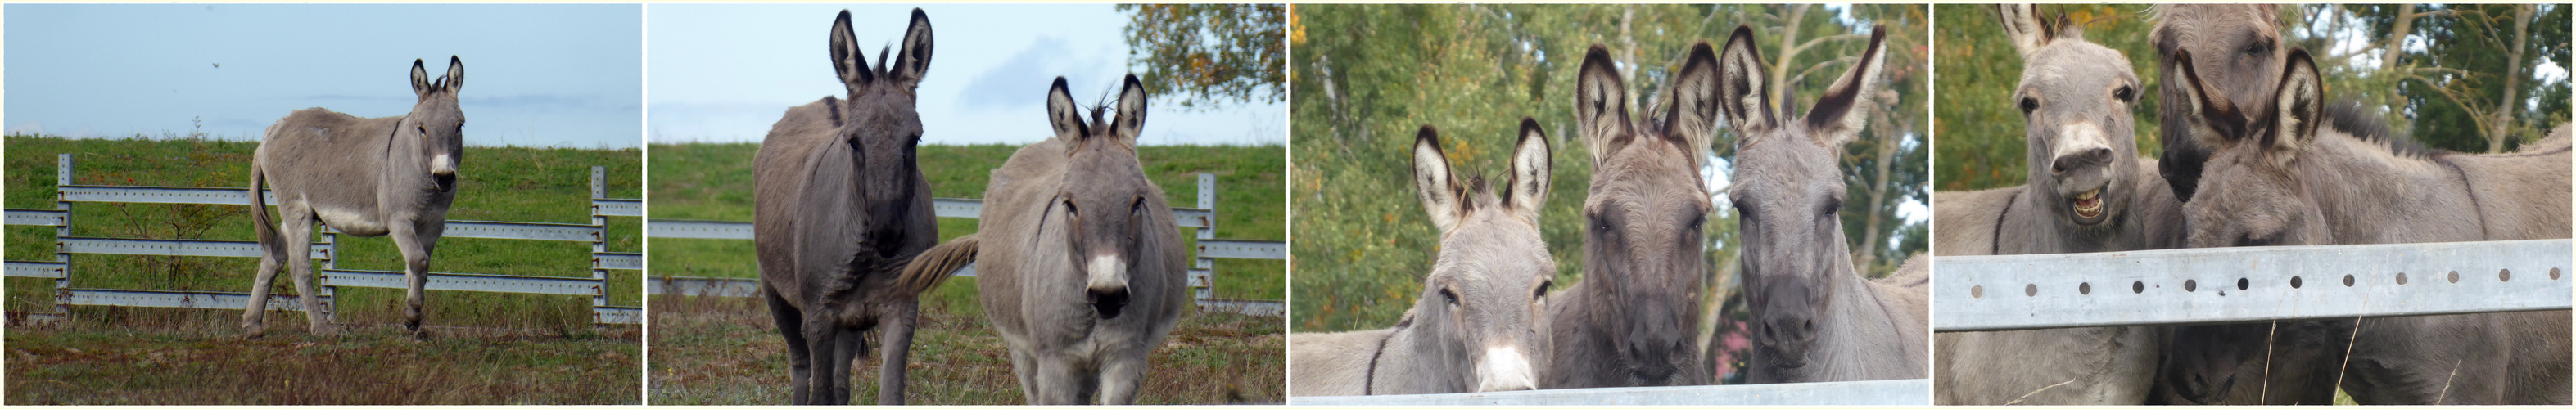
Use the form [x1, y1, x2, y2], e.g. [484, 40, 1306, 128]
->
[2169, 49, 2571, 404]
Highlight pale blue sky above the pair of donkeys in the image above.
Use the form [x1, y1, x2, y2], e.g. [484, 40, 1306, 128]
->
[644, 5, 1288, 144]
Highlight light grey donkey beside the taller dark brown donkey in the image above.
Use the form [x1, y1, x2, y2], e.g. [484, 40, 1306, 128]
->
[920, 74, 1190, 404]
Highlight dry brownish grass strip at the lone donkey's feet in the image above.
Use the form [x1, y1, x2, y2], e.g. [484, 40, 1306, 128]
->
[7, 317, 641, 404]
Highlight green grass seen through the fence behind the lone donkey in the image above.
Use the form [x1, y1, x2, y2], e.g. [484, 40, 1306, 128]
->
[0, 137, 641, 404]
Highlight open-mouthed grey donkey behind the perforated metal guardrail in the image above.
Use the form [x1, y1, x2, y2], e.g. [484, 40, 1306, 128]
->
[1932, 5, 2182, 404]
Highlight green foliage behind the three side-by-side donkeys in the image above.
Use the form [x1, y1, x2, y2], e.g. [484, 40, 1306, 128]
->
[1288, 5, 1929, 332]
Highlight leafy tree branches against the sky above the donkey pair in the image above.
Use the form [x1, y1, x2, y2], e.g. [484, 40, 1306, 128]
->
[1118, 5, 1288, 108]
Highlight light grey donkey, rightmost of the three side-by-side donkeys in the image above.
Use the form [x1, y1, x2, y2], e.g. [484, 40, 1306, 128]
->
[1700, 25, 1932, 384]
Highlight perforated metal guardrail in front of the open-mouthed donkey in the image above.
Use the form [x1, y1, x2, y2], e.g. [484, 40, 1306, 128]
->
[1932, 239, 2576, 332]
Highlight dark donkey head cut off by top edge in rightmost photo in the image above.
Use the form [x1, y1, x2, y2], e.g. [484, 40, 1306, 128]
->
[2149, 5, 2288, 200]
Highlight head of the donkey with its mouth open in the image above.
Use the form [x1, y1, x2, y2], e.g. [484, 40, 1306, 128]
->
[1999, 5, 2143, 234]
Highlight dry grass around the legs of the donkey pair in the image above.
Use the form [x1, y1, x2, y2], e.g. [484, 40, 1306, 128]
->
[649, 278, 1288, 404]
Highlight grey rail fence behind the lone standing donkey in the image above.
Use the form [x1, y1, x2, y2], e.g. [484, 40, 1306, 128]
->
[5, 155, 644, 324]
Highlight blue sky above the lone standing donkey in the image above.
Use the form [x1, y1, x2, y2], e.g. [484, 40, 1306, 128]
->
[0, 5, 644, 146]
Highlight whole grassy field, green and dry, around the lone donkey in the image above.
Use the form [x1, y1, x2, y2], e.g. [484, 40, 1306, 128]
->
[0, 137, 641, 404]
